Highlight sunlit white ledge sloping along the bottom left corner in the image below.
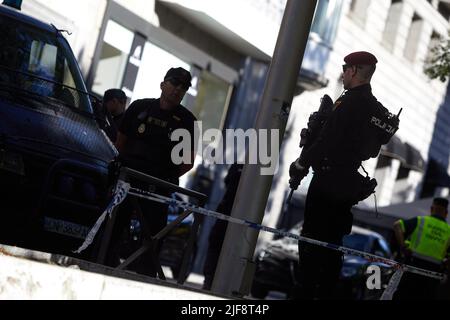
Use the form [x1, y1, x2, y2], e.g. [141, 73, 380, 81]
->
[0, 245, 227, 300]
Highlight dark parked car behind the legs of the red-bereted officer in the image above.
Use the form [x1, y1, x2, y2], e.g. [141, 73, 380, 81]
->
[251, 223, 393, 300]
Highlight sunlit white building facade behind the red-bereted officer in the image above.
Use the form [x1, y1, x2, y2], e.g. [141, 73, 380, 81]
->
[265, 0, 450, 244]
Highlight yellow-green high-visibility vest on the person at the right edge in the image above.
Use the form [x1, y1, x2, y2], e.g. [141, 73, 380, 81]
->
[402, 216, 450, 263]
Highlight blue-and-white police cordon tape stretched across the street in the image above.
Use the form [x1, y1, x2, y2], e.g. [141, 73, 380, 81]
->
[75, 180, 446, 288]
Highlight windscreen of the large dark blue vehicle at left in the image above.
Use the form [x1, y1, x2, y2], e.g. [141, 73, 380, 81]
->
[0, 16, 91, 112]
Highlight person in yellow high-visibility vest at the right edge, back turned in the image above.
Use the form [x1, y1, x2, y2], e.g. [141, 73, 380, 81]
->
[394, 198, 450, 300]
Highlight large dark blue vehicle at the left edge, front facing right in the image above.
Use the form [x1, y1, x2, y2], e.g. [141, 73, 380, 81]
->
[0, 5, 117, 254]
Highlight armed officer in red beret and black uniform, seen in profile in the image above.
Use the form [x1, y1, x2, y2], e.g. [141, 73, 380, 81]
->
[290, 51, 394, 299]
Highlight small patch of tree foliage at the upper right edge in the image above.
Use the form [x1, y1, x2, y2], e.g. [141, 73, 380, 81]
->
[424, 33, 450, 82]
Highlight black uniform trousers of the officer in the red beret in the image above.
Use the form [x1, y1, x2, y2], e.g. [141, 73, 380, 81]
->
[293, 169, 357, 300]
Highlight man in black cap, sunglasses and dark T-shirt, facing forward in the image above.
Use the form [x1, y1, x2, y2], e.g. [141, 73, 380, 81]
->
[108, 67, 197, 276]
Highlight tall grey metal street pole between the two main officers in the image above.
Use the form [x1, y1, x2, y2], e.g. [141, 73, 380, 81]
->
[212, 0, 317, 296]
